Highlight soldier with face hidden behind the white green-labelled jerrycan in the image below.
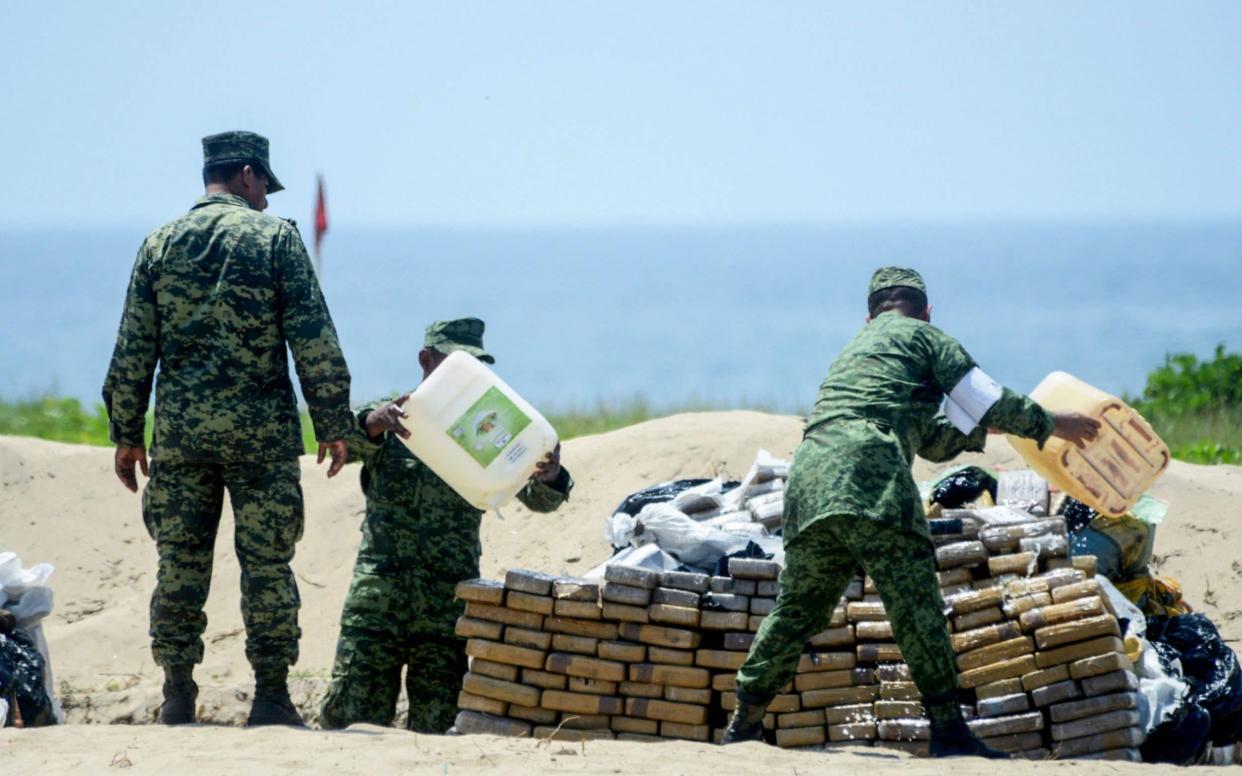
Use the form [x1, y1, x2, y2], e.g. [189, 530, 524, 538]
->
[319, 318, 574, 734]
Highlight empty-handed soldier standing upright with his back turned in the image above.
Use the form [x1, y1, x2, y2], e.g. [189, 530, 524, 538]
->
[103, 132, 353, 725]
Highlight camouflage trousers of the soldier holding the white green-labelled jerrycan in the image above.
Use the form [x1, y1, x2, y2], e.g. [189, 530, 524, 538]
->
[319, 556, 478, 734]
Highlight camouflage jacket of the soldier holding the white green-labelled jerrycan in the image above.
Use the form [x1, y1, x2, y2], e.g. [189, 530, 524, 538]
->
[349, 400, 574, 582]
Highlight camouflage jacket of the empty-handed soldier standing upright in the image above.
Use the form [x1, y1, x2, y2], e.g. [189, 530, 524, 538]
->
[103, 194, 353, 463]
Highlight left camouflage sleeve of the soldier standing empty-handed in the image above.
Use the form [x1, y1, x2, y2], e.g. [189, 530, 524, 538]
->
[103, 242, 159, 448]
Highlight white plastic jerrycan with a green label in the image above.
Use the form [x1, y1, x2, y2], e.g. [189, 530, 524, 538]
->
[401, 350, 556, 510]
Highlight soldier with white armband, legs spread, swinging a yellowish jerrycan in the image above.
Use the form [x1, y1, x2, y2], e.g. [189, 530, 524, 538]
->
[725, 267, 1098, 757]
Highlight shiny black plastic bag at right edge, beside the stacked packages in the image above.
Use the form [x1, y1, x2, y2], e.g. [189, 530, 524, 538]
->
[1148, 612, 1242, 746]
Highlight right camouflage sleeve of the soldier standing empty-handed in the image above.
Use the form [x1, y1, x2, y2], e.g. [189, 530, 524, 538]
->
[276, 225, 356, 442]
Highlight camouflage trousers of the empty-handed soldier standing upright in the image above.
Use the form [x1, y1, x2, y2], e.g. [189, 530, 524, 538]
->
[143, 459, 303, 672]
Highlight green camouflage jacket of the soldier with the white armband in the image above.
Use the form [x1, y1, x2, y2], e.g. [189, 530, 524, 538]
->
[781, 312, 1052, 543]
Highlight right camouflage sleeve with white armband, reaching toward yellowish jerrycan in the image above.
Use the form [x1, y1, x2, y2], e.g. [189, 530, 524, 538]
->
[920, 327, 1053, 446]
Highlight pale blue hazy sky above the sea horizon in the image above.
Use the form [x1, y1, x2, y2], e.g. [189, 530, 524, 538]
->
[0, 0, 1242, 227]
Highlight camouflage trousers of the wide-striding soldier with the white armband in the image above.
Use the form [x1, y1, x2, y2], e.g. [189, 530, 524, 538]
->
[738, 517, 958, 715]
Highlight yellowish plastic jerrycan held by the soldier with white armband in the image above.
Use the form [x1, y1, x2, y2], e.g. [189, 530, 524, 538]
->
[1009, 371, 1169, 517]
